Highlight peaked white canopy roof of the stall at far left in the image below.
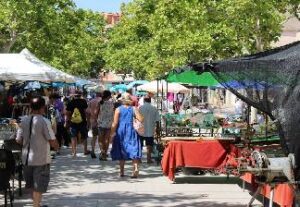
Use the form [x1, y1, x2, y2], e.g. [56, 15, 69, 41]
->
[0, 49, 75, 83]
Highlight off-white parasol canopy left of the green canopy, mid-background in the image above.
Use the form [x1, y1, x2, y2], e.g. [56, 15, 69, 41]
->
[137, 80, 190, 93]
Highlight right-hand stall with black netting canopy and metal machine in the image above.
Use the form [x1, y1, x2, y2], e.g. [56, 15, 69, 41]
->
[186, 42, 300, 206]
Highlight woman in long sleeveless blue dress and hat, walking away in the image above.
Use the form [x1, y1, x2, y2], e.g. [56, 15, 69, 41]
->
[111, 94, 144, 178]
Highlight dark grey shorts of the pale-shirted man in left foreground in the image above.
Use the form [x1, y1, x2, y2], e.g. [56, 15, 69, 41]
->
[24, 164, 50, 193]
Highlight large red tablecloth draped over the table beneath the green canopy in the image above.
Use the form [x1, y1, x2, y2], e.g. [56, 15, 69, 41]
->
[162, 140, 238, 180]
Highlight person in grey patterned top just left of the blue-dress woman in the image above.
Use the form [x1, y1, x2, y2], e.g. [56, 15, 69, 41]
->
[98, 90, 114, 161]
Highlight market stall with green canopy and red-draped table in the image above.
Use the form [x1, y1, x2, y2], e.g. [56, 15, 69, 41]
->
[161, 66, 243, 180]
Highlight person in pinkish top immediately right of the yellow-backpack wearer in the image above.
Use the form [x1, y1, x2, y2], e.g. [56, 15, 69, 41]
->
[87, 91, 102, 159]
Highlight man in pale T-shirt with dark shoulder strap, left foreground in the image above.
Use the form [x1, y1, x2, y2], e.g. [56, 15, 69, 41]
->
[16, 97, 58, 207]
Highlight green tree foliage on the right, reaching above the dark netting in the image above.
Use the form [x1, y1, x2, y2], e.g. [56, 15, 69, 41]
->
[105, 0, 299, 78]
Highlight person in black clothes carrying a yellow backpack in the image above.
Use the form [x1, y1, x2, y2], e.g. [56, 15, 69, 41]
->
[65, 91, 90, 158]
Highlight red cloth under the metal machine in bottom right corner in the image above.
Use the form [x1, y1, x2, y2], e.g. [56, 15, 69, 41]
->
[241, 173, 294, 207]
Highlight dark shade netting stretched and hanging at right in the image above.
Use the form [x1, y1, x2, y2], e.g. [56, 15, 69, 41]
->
[192, 42, 300, 180]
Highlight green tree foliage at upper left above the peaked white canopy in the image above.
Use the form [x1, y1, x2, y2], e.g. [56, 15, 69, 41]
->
[0, 0, 105, 76]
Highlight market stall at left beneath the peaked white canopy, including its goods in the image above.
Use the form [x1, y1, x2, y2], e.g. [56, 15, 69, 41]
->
[0, 49, 76, 195]
